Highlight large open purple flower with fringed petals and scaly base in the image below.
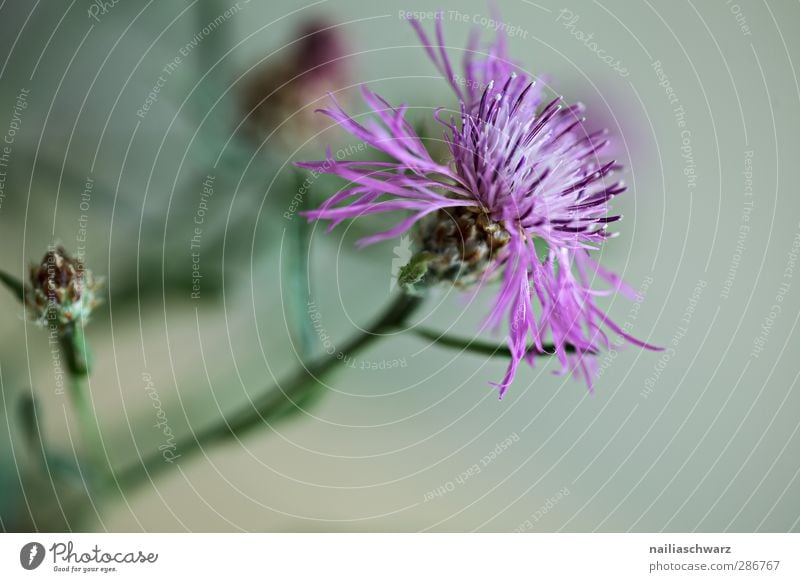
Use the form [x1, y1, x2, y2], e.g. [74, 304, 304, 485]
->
[298, 21, 659, 398]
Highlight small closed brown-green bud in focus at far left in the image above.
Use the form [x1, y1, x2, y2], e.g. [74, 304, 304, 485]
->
[25, 246, 100, 326]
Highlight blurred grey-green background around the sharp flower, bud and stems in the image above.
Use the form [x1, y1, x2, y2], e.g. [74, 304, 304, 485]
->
[0, 0, 800, 532]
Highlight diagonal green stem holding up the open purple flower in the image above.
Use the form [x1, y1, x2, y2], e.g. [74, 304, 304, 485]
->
[114, 294, 423, 491]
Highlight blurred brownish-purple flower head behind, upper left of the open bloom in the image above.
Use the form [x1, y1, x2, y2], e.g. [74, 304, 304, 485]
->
[242, 20, 350, 148]
